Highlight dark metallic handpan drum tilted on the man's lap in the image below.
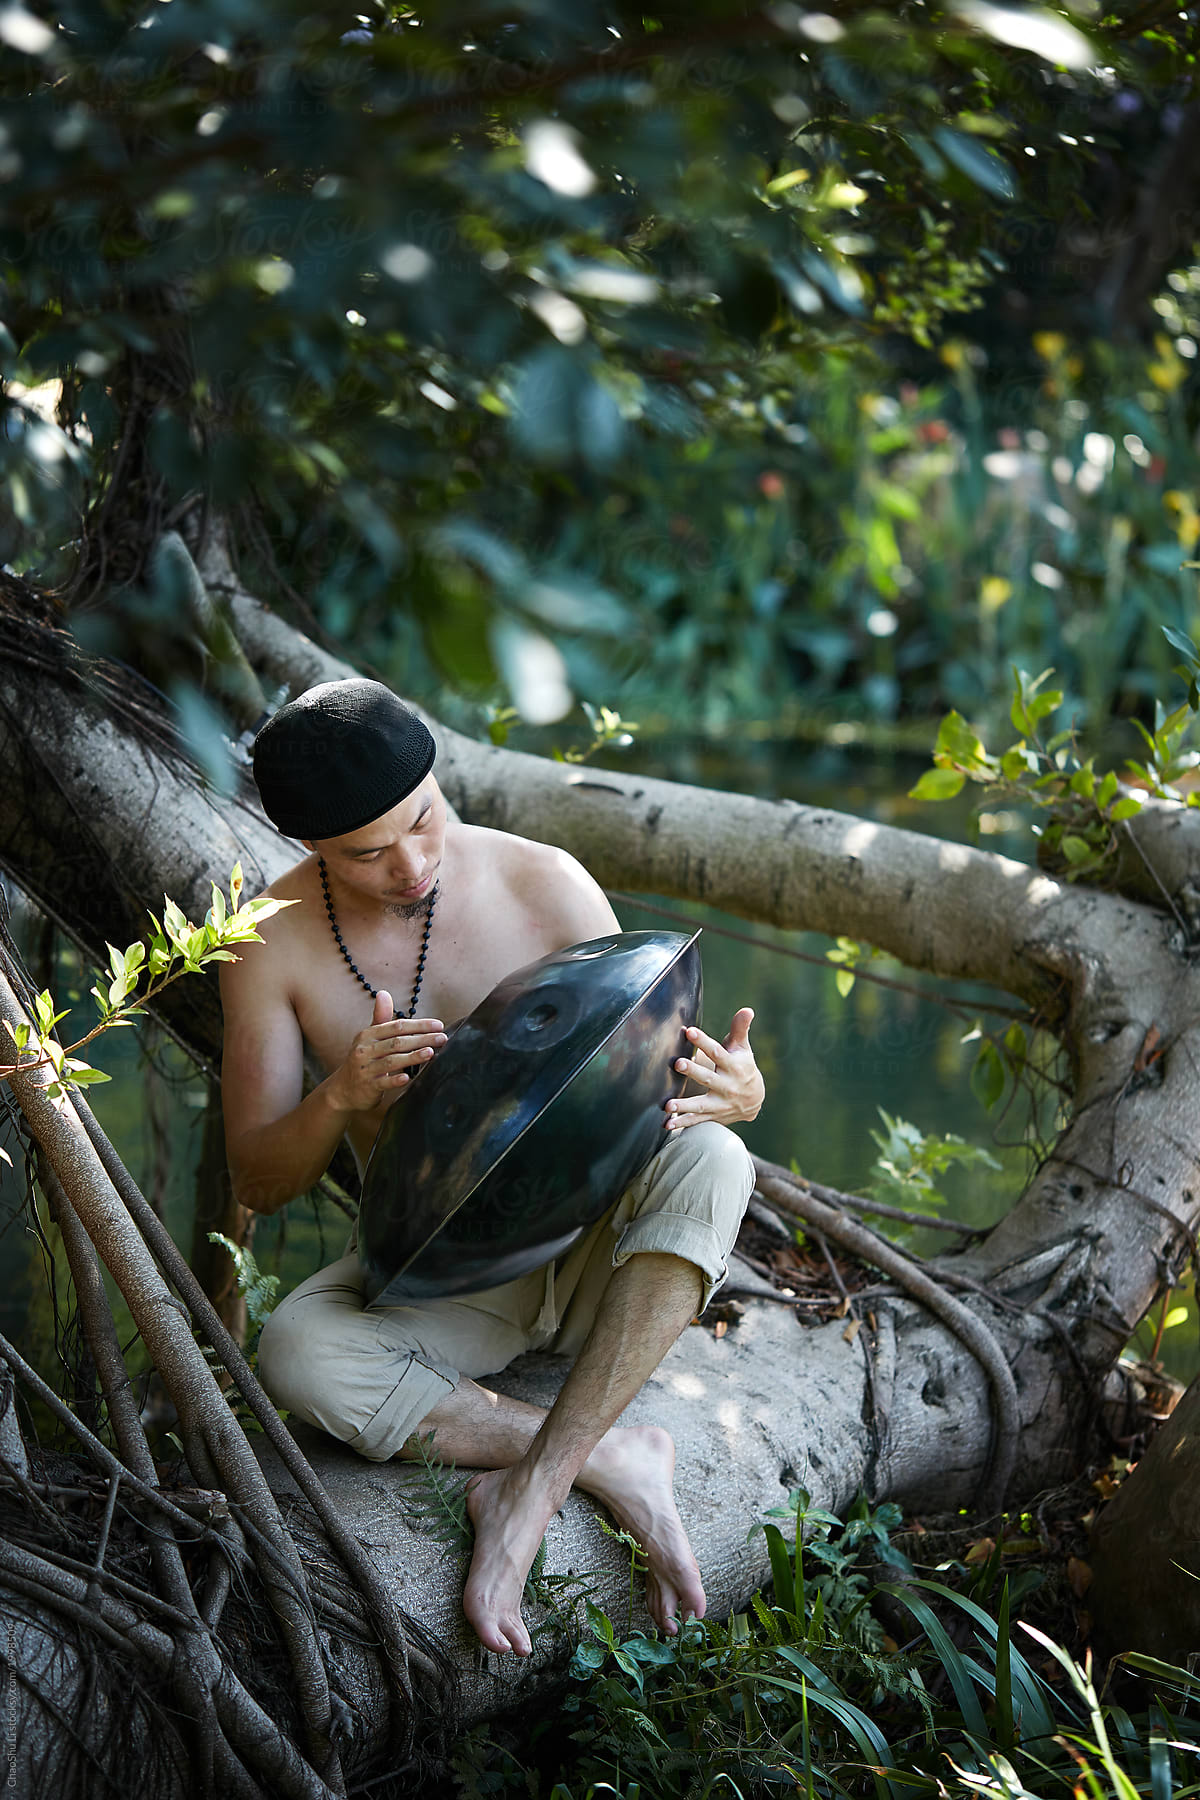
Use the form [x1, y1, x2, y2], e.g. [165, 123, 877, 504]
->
[358, 931, 702, 1307]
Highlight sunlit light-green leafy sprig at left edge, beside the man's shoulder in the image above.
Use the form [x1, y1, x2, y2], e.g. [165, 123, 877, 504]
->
[0, 862, 287, 1100]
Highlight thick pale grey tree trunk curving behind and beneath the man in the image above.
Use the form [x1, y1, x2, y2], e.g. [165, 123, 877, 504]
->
[0, 565, 1200, 1756]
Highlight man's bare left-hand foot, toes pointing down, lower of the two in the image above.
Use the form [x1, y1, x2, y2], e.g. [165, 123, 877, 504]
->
[462, 1469, 558, 1656]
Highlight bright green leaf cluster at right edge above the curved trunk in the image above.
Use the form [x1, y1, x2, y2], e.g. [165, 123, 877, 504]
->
[910, 655, 1200, 885]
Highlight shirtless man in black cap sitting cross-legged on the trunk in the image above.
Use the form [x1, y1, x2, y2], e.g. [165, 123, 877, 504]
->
[221, 680, 763, 1656]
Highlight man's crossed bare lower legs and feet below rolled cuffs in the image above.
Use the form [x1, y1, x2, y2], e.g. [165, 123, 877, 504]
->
[401, 1253, 705, 1656]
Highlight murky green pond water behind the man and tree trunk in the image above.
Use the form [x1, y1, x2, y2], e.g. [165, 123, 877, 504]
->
[0, 740, 1200, 1379]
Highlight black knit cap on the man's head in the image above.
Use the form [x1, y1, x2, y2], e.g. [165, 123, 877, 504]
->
[254, 680, 435, 839]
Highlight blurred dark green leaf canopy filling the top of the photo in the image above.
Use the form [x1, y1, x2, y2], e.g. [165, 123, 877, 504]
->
[0, 0, 1193, 731]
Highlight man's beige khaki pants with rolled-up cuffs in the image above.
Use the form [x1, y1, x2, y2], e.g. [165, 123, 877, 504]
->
[259, 1123, 754, 1462]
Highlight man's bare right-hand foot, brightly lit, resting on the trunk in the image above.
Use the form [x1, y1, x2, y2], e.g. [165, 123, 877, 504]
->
[576, 1426, 707, 1636]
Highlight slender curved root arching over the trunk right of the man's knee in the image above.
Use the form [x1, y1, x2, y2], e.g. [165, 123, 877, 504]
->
[754, 1156, 1020, 1512]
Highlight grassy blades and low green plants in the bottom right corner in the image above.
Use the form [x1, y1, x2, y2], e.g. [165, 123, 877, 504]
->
[457, 1494, 1200, 1800]
